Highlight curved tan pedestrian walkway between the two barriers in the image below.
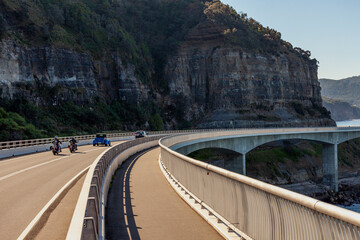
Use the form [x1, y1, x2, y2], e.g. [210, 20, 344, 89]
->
[106, 148, 223, 240]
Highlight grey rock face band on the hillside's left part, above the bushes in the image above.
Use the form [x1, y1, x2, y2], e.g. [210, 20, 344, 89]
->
[0, 41, 148, 104]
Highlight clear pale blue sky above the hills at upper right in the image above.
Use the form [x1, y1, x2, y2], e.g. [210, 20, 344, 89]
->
[221, 0, 360, 79]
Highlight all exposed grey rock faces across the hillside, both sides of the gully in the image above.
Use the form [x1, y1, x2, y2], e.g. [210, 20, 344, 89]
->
[0, 35, 334, 128]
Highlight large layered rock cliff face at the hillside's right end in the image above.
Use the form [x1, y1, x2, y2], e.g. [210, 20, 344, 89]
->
[166, 23, 334, 128]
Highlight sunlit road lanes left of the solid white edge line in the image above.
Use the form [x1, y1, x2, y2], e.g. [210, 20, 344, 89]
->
[0, 145, 114, 240]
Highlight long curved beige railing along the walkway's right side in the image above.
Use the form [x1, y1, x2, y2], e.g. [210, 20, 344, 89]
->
[159, 133, 360, 240]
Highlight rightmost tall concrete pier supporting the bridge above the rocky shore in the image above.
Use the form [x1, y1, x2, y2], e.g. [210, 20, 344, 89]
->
[322, 144, 339, 192]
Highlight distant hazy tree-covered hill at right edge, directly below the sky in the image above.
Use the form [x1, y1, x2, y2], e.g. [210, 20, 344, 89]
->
[319, 76, 360, 107]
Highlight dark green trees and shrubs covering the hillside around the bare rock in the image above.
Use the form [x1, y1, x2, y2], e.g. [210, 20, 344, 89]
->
[0, 0, 324, 140]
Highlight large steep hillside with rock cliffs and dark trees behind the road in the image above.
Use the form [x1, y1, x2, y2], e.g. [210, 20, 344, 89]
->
[0, 0, 334, 140]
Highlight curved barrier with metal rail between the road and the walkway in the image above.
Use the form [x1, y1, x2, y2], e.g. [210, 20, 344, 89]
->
[66, 136, 163, 240]
